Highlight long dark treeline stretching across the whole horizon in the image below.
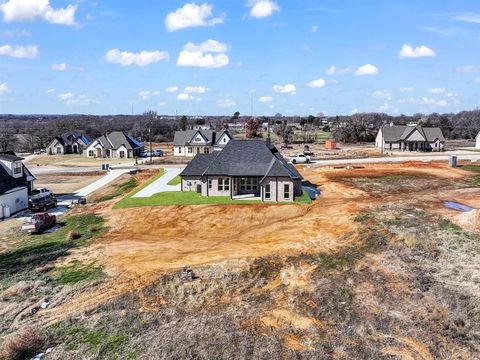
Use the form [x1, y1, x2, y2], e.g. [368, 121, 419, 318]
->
[0, 110, 480, 152]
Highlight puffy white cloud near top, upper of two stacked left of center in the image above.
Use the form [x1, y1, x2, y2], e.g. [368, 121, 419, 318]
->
[165, 3, 223, 32]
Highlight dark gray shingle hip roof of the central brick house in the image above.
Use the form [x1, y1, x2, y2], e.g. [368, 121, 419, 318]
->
[180, 140, 302, 179]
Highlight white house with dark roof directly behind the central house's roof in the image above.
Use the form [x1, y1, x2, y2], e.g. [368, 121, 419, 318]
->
[173, 129, 233, 157]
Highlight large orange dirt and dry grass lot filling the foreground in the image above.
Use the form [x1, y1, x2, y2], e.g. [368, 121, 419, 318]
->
[0, 162, 480, 359]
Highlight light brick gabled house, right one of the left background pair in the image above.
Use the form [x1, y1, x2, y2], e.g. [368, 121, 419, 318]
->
[84, 131, 144, 159]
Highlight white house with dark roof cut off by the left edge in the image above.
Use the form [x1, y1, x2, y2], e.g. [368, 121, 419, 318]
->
[0, 151, 35, 218]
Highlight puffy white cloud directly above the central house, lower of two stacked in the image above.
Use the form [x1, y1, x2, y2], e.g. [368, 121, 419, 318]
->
[177, 39, 230, 68]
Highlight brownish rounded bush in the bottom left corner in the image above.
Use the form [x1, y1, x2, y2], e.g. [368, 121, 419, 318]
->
[0, 328, 46, 360]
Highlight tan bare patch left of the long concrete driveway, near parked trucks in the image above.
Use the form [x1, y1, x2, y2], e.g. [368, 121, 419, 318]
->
[35, 171, 105, 195]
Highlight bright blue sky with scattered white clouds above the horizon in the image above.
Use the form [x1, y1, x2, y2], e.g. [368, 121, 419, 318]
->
[0, 0, 480, 115]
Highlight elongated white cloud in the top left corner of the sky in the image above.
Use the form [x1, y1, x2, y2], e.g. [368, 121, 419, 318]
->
[0, 0, 78, 26]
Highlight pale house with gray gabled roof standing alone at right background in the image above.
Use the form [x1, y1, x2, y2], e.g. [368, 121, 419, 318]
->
[375, 125, 445, 151]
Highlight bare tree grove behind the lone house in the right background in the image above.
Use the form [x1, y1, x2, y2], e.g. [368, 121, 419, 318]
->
[329, 110, 480, 143]
